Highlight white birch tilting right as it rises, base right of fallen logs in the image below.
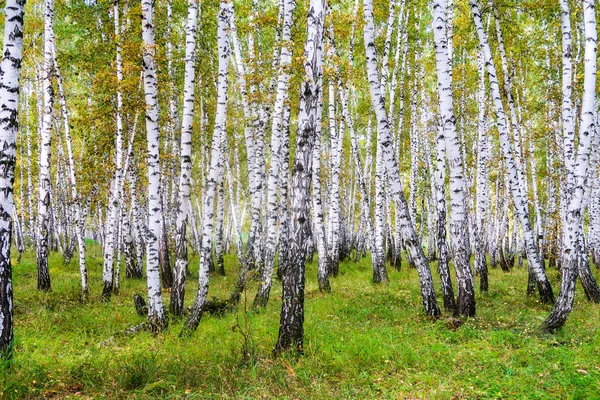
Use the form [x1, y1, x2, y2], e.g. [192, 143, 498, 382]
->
[184, 1, 233, 331]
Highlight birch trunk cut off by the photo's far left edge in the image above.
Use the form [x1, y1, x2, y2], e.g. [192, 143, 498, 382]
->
[0, 0, 26, 360]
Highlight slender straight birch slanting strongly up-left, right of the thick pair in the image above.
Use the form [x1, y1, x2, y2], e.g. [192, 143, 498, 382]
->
[469, 0, 554, 303]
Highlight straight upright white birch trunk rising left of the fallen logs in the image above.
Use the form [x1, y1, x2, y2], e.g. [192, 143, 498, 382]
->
[142, 0, 167, 332]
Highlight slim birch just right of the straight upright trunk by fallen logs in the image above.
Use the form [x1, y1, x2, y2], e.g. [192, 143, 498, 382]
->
[170, 0, 198, 315]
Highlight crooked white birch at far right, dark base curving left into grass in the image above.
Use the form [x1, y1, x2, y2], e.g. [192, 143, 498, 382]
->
[541, 0, 598, 332]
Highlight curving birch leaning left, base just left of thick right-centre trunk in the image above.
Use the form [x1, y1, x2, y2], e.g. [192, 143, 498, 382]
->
[363, 0, 440, 316]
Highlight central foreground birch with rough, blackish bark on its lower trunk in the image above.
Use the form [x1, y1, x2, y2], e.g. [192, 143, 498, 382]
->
[276, 0, 325, 352]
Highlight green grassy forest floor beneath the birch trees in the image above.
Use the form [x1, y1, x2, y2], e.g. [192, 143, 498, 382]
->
[0, 245, 600, 399]
